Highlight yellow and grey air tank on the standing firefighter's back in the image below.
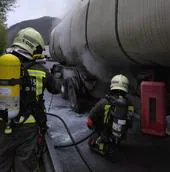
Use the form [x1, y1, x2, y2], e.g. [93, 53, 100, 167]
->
[0, 54, 21, 133]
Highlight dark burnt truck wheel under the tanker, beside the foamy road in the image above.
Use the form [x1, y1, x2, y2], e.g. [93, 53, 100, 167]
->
[68, 80, 80, 113]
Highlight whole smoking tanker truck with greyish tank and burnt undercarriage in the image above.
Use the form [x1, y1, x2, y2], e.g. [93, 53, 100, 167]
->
[49, 0, 170, 134]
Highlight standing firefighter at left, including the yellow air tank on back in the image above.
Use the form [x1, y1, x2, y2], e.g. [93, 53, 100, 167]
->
[0, 28, 58, 172]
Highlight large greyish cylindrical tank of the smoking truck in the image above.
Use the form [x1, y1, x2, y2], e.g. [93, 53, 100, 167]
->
[50, 0, 170, 112]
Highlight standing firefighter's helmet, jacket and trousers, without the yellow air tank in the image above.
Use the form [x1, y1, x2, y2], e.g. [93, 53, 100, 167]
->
[0, 27, 58, 172]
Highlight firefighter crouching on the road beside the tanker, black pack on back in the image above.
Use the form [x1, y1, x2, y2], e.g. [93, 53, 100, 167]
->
[87, 74, 134, 158]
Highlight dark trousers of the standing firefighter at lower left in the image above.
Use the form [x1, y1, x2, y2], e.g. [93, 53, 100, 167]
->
[0, 124, 38, 172]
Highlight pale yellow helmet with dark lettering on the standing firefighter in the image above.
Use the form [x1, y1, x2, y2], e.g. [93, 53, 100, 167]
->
[12, 27, 44, 59]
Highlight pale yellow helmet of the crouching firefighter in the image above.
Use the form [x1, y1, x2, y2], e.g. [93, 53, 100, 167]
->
[110, 74, 129, 93]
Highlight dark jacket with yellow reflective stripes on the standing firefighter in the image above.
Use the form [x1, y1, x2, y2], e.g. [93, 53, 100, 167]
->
[19, 62, 58, 125]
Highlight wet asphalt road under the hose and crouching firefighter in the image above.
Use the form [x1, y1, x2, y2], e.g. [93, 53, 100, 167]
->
[45, 92, 170, 172]
